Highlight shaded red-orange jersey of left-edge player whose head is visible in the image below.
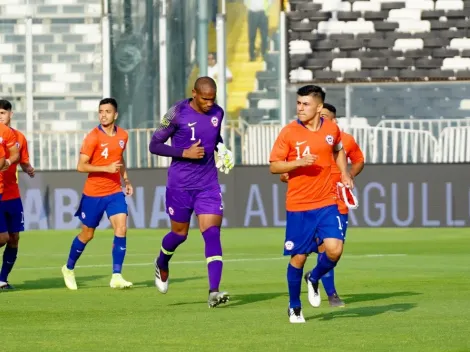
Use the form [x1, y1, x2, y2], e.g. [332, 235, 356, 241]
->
[2, 128, 29, 200]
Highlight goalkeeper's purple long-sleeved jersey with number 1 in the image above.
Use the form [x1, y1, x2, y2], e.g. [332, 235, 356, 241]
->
[149, 99, 224, 190]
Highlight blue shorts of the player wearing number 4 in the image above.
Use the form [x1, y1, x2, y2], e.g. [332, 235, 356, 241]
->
[75, 192, 127, 229]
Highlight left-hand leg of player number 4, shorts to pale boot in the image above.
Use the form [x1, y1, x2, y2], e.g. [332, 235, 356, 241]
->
[62, 195, 105, 290]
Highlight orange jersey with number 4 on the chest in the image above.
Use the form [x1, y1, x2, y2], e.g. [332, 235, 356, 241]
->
[80, 126, 128, 197]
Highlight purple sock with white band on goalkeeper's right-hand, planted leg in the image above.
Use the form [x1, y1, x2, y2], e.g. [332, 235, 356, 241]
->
[202, 226, 223, 292]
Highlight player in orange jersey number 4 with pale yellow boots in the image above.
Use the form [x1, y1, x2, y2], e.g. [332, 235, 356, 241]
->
[62, 98, 133, 290]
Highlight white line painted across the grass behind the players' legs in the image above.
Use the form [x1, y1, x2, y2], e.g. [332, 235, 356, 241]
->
[14, 254, 407, 271]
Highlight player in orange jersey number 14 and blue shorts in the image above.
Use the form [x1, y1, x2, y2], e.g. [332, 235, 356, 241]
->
[269, 85, 353, 323]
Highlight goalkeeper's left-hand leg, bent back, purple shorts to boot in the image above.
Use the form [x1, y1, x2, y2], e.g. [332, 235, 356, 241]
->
[155, 188, 193, 293]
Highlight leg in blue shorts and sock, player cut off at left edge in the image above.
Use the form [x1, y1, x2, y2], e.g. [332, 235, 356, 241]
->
[0, 198, 24, 290]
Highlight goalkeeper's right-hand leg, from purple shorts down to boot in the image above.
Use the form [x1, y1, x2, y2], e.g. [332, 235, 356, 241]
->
[194, 187, 230, 308]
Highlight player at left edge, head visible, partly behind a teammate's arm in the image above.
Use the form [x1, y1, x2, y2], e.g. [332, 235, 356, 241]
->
[0, 100, 34, 290]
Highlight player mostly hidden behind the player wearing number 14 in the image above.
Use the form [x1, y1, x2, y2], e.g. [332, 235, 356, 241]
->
[304, 103, 364, 307]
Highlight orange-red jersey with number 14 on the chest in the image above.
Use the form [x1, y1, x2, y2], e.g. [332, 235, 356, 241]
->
[269, 120, 341, 211]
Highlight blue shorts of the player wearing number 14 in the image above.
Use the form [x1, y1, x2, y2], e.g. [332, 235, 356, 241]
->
[284, 205, 344, 255]
